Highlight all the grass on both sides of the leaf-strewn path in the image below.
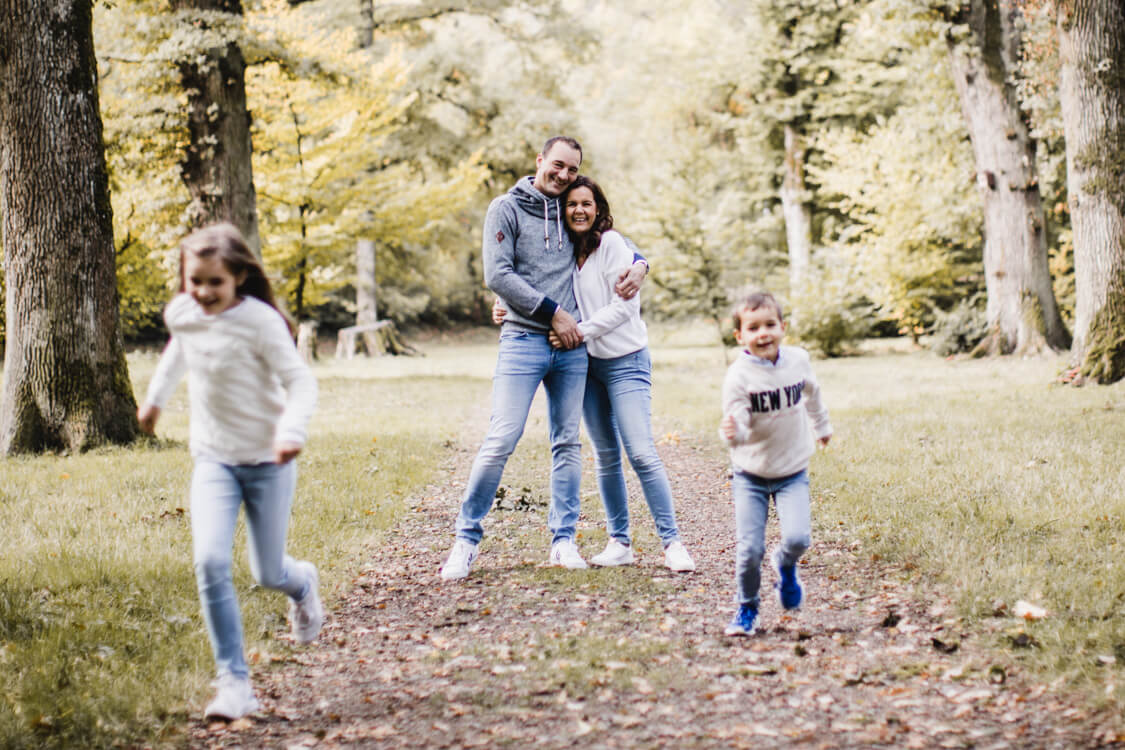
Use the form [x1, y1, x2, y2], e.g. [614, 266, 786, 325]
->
[0, 329, 1125, 748]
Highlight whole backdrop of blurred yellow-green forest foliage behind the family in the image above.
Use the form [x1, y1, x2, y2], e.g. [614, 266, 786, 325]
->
[0, 0, 1089, 354]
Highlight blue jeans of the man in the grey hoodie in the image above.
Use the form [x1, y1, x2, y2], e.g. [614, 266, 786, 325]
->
[457, 329, 586, 544]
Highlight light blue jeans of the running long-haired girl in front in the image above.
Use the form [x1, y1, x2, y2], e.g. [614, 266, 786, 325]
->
[191, 459, 312, 678]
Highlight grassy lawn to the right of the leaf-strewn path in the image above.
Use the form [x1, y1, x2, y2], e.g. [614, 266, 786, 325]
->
[654, 330, 1125, 710]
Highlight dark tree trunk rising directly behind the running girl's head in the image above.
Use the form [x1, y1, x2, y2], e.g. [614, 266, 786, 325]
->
[172, 0, 262, 257]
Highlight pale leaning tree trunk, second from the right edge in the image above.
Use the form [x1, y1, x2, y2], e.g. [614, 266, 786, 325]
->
[950, 0, 1070, 354]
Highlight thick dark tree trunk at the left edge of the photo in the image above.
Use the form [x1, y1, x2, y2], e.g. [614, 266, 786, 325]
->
[0, 0, 137, 455]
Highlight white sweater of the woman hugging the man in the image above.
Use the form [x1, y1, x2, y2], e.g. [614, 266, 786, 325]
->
[574, 229, 648, 360]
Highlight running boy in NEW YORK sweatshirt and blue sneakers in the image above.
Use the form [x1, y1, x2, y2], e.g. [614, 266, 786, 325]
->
[719, 292, 833, 635]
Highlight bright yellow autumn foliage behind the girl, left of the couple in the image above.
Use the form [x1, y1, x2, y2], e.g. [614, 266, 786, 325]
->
[96, 0, 487, 335]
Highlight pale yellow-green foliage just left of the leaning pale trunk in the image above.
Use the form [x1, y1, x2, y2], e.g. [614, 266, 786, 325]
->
[810, 34, 982, 333]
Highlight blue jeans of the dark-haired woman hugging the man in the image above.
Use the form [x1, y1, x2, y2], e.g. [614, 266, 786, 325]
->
[582, 347, 680, 546]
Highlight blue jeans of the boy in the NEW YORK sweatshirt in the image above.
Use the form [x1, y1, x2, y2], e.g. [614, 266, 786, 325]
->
[731, 470, 812, 608]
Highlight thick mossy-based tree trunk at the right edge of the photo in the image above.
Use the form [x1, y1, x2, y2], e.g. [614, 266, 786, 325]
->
[1059, 0, 1125, 382]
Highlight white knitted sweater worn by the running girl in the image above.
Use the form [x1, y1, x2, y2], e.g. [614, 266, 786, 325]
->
[145, 293, 316, 464]
